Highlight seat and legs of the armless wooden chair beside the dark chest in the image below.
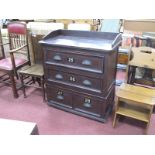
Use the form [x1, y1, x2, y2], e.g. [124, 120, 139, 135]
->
[19, 64, 45, 101]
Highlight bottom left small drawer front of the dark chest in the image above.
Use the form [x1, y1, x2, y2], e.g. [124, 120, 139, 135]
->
[46, 84, 72, 108]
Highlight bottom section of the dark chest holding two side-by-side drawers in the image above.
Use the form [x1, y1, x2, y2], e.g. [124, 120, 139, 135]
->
[46, 83, 114, 122]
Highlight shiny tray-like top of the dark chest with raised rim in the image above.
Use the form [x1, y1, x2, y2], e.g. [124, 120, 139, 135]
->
[40, 30, 121, 51]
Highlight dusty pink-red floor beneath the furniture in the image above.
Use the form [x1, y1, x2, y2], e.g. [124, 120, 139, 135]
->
[0, 70, 155, 135]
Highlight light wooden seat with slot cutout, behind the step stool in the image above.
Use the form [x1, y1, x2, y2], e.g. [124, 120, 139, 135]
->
[127, 46, 155, 87]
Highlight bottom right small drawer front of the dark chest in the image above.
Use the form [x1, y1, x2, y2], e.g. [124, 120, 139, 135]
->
[73, 94, 105, 117]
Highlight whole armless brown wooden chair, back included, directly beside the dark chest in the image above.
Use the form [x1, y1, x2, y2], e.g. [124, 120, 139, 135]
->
[19, 35, 45, 101]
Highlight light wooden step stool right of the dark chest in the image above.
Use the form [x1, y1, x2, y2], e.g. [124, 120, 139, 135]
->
[113, 83, 155, 134]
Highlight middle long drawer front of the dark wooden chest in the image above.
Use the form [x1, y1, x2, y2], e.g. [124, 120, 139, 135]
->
[46, 67, 102, 92]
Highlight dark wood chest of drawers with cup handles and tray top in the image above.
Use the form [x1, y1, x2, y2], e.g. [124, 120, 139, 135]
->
[40, 30, 121, 122]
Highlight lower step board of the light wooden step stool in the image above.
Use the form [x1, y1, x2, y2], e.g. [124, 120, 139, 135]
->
[116, 107, 149, 122]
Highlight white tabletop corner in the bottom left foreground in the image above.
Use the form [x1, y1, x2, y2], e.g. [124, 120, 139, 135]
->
[0, 119, 39, 135]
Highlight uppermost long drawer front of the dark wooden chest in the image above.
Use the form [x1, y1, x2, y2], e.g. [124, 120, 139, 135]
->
[45, 49, 104, 73]
